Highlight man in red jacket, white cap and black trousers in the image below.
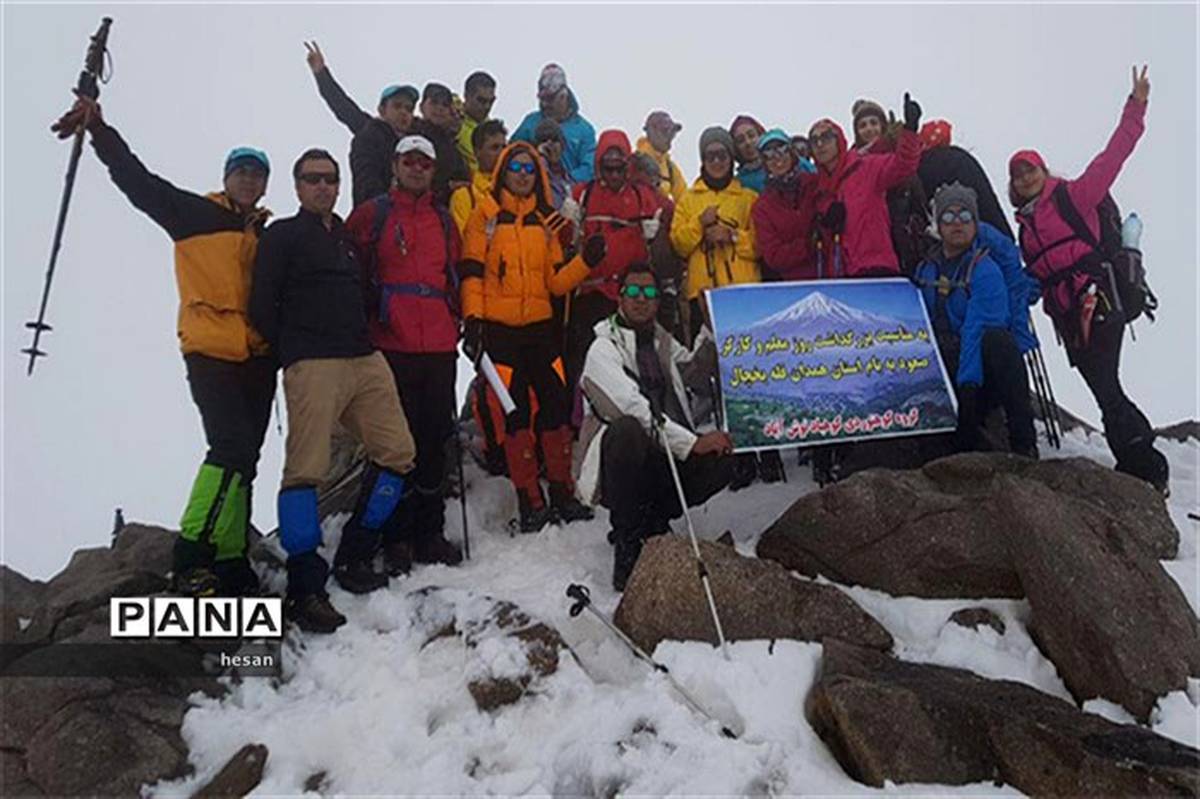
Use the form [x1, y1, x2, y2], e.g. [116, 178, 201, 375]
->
[347, 136, 462, 576]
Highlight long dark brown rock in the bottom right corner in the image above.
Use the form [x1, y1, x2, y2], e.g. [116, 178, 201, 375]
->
[805, 641, 1200, 797]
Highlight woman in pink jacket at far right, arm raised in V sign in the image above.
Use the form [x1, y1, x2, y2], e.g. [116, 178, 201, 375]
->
[1008, 67, 1169, 493]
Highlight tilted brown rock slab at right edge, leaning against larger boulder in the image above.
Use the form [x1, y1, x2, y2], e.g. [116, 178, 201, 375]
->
[997, 477, 1200, 722]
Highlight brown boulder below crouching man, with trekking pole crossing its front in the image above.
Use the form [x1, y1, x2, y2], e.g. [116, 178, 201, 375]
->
[613, 527, 892, 651]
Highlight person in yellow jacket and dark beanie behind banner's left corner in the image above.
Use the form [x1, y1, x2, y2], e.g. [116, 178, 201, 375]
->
[671, 127, 762, 337]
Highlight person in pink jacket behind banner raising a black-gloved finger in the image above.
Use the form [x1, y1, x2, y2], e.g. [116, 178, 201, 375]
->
[809, 94, 920, 277]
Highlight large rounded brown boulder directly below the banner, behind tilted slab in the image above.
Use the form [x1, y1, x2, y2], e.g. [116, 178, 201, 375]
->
[757, 452, 1180, 599]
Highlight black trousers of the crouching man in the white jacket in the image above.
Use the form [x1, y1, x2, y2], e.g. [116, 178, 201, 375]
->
[600, 416, 733, 540]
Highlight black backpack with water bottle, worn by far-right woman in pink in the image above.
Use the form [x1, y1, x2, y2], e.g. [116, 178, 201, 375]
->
[1050, 182, 1158, 324]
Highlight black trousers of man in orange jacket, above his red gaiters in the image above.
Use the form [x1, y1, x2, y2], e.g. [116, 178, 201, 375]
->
[484, 319, 571, 433]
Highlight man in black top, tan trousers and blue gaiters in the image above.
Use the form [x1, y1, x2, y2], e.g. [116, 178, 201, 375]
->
[250, 150, 416, 632]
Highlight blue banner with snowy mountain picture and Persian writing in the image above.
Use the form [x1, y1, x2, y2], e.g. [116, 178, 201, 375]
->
[708, 278, 958, 450]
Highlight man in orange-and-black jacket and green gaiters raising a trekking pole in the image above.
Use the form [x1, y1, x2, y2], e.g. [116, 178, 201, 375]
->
[62, 94, 277, 596]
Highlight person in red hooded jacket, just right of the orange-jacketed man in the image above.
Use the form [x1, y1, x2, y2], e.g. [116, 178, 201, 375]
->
[562, 131, 668, 391]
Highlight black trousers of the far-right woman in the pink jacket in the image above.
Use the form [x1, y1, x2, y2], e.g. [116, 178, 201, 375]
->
[1067, 313, 1154, 460]
